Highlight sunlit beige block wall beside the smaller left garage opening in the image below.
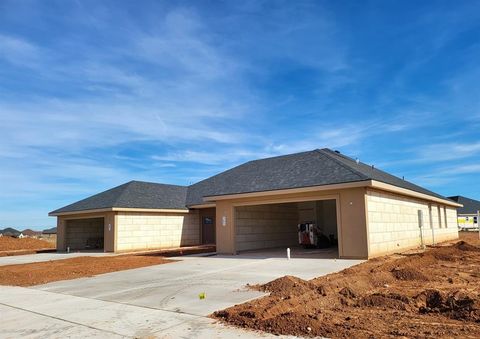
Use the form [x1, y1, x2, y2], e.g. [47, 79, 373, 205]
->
[116, 210, 200, 252]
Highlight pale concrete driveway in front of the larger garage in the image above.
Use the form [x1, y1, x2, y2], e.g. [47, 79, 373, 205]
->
[0, 252, 361, 338]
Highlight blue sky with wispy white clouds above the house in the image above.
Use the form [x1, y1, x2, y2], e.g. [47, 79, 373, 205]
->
[0, 0, 480, 228]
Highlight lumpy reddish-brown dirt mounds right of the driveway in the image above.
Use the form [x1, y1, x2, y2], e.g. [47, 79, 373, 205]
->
[212, 233, 480, 338]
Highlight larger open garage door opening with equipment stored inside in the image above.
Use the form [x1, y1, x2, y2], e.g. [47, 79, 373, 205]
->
[235, 199, 339, 257]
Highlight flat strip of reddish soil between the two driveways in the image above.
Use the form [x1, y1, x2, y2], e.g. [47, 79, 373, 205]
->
[0, 255, 174, 286]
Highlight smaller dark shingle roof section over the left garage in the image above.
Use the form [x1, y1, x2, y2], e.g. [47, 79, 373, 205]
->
[50, 181, 187, 214]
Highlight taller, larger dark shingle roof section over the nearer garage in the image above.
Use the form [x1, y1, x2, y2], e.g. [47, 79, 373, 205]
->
[187, 149, 446, 206]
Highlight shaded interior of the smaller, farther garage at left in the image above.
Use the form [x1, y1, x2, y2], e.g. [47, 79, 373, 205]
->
[65, 218, 104, 251]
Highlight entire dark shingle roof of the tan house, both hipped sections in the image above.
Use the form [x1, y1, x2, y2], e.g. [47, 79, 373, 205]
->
[51, 148, 456, 214]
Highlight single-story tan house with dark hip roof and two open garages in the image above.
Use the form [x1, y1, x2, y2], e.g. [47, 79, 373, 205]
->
[49, 149, 461, 258]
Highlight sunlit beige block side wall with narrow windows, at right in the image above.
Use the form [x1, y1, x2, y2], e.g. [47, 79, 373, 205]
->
[366, 189, 458, 257]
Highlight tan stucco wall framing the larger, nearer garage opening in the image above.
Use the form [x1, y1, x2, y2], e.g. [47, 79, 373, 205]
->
[216, 188, 368, 258]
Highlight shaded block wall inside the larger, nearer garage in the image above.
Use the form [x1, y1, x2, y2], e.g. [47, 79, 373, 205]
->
[235, 203, 298, 251]
